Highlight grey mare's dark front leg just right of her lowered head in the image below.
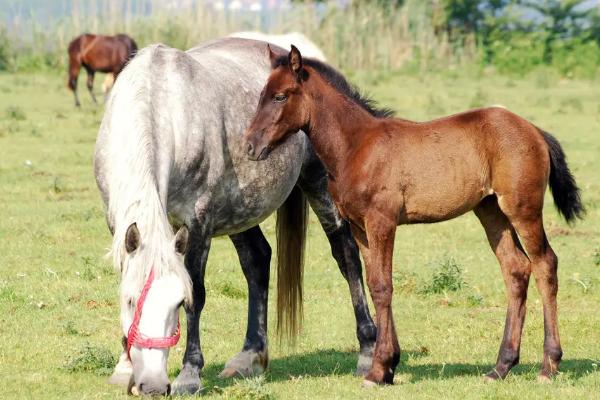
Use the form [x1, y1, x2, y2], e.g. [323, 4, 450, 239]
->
[172, 221, 211, 394]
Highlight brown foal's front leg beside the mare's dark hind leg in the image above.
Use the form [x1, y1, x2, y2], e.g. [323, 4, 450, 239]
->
[353, 211, 400, 386]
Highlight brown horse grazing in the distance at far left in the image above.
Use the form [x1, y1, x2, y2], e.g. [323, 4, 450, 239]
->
[68, 33, 137, 107]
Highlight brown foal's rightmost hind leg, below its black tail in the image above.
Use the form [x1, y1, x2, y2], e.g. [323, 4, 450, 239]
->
[499, 192, 562, 382]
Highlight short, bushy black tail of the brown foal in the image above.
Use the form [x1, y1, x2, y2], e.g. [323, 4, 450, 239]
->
[541, 131, 585, 223]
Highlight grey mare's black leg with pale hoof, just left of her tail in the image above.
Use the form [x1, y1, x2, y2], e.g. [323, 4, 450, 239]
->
[220, 226, 271, 378]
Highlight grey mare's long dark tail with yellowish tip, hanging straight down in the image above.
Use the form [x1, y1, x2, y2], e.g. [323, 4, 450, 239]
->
[276, 187, 308, 343]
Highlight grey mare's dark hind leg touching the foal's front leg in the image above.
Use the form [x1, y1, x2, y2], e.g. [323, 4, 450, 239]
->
[298, 160, 377, 376]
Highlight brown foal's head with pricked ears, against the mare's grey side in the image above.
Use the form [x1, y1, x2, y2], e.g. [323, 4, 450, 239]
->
[245, 45, 309, 160]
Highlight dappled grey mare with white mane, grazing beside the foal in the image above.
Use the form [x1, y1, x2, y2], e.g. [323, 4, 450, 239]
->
[94, 38, 376, 394]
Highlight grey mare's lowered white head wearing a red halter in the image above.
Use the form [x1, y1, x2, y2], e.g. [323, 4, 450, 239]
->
[113, 223, 192, 394]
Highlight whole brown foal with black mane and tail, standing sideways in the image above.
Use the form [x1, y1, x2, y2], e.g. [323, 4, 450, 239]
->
[246, 46, 584, 384]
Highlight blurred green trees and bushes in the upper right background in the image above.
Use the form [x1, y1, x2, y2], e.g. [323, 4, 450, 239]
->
[302, 0, 600, 78]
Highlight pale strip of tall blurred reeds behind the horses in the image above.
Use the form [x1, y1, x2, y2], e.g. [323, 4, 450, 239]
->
[0, 0, 464, 70]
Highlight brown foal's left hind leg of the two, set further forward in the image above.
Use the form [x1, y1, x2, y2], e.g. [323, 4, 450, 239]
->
[474, 196, 531, 380]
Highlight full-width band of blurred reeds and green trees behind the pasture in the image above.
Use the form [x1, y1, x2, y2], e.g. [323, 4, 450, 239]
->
[0, 0, 600, 79]
